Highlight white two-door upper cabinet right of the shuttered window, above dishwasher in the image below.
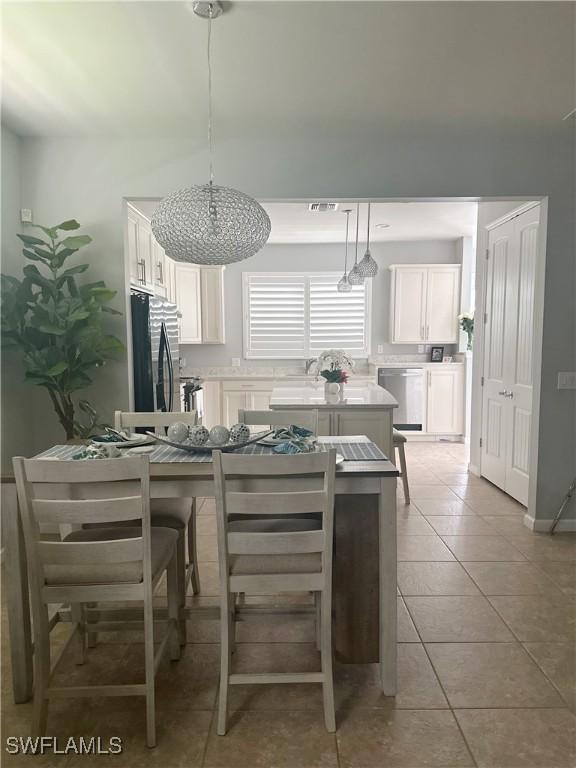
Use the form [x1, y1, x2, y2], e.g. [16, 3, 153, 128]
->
[390, 264, 460, 344]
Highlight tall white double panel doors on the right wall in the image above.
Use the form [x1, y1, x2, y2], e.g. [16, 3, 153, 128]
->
[481, 206, 540, 504]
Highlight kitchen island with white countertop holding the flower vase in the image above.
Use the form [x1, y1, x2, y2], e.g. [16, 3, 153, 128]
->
[270, 379, 398, 462]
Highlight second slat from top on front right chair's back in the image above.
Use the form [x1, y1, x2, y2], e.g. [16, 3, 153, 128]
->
[226, 491, 326, 517]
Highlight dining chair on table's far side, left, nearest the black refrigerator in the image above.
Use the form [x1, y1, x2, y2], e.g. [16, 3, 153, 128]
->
[114, 411, 200, 604]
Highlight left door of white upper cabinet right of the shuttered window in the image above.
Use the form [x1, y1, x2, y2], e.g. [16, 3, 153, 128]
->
[390, 266, 426, 344]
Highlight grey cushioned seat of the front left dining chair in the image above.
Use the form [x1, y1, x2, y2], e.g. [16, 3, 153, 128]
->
[45, 527, 178, 586]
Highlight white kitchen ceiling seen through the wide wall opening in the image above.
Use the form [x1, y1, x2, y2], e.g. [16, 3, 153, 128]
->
[132, 200, 478, 243]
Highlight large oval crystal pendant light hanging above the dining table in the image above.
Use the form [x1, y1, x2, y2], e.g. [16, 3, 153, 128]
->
[151, 2, 270, 264]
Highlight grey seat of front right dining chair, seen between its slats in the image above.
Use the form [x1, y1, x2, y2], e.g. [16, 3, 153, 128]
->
[228, 517, 322, 576]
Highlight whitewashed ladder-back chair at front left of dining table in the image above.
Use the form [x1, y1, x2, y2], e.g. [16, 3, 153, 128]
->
[13, 456, 183, 747]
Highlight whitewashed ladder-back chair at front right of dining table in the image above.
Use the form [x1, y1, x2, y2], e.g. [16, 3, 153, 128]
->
[213, 450, 336, 735]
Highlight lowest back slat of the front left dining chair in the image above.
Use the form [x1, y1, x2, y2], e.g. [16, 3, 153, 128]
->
[36, 536, 144, 565]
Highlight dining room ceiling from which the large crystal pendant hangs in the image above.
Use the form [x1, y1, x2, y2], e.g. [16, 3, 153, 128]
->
[2, 0, 574, 136]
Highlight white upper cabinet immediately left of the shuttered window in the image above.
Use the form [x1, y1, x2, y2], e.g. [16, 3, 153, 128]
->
[173, 262, 224, 344]
